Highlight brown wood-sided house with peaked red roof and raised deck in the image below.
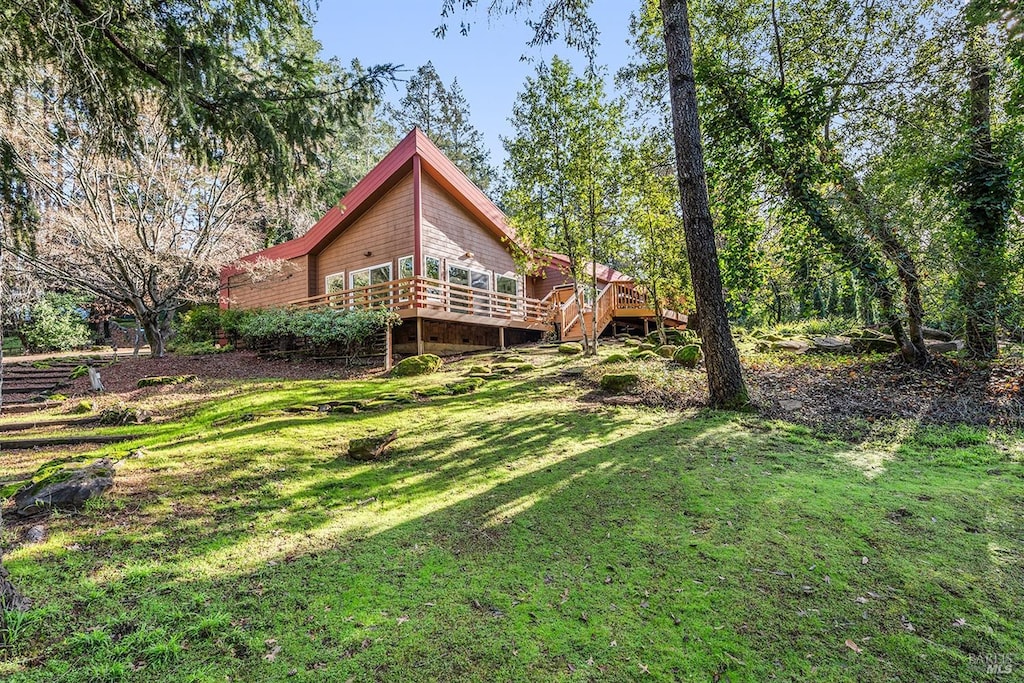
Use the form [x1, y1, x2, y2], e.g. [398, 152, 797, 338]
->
[221, 129, 686, 353]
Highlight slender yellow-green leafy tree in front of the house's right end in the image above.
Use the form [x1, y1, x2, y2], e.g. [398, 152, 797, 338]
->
[504, 56, 623, 353]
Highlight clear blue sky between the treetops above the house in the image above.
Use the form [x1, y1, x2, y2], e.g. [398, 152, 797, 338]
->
[314, 0, 640, 164]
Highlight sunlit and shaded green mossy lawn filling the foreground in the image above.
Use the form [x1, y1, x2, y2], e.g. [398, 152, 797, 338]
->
[0, 349, 1024, 681]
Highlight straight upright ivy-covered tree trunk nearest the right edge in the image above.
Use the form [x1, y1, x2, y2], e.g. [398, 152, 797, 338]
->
[961, 29, 1011, 358]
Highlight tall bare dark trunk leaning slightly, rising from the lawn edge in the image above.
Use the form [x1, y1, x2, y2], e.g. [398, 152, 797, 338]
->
[660, 0, 750, 409]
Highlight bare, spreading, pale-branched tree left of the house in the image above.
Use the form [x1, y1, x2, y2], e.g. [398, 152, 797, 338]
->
[9, 104, 258, 356]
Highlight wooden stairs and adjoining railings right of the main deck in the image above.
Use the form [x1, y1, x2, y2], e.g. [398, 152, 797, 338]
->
[551, 283, 686, 341]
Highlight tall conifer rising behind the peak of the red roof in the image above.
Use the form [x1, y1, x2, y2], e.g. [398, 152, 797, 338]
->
[388, 61, 498, 191]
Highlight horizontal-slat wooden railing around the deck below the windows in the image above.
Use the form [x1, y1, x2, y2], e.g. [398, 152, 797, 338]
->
[290, 278, 550, 323]
